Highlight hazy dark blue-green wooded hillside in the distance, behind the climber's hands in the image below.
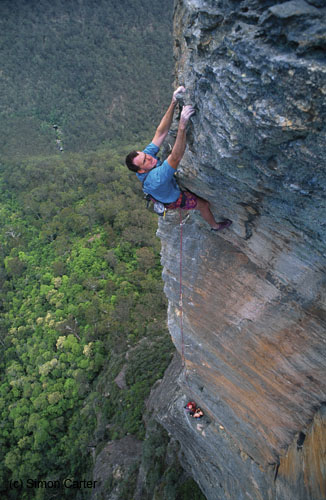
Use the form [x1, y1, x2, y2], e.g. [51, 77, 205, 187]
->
[0, 0, 173, 156]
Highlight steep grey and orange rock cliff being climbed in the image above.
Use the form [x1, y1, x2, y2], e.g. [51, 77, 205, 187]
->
[158, 0, 326, 500]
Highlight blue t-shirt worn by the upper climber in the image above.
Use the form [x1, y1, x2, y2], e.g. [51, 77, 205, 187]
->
[136, 142, 181, 203]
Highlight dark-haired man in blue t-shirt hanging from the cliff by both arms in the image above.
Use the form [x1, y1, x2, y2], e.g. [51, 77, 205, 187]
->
[126, 87, 232, 231]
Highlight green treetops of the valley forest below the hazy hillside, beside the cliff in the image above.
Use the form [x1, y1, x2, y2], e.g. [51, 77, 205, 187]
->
[0, 147, 173, 498]
